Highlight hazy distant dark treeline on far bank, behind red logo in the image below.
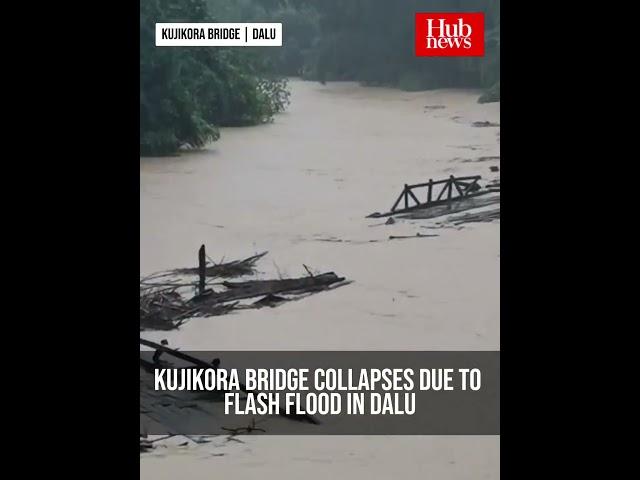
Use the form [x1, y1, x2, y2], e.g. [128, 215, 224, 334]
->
[208, 0, 500, 95]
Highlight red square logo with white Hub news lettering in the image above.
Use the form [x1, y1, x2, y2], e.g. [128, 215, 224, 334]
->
[416, 13, 484, 57]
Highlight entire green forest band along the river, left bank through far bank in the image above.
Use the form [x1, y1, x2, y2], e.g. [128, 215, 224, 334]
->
[140, 0, 500, 155]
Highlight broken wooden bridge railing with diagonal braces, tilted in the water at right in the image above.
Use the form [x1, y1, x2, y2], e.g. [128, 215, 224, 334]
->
[368, 175, 491, 218]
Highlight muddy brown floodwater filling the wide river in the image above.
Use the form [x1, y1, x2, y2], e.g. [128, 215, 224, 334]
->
[140, 80, 500, 480]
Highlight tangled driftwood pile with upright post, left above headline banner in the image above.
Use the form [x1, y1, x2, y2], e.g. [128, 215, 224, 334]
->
[140, 245, 346, 331]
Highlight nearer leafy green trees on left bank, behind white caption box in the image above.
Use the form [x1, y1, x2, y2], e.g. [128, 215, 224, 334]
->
[140, 0, 289, 155]
